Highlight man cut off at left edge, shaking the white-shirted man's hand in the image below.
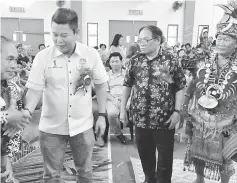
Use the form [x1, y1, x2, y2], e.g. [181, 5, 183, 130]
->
[0, 36, 31, 183]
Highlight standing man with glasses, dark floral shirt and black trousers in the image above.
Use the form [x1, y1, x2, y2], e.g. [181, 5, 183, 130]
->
[120, 26, 186, 183]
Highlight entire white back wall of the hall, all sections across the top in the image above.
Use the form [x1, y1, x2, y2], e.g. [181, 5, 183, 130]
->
[0, 0, 230, 46]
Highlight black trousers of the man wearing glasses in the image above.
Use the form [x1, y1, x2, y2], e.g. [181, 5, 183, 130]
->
[135, 127, 175, 183]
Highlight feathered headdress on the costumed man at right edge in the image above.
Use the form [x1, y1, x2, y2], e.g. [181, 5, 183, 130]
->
[216, 1, 237, 38]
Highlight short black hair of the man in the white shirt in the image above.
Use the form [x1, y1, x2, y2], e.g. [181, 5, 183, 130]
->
[51, 8, 78, 34]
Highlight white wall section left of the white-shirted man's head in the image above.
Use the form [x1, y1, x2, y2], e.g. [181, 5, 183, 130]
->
[0, 0, 71, 45]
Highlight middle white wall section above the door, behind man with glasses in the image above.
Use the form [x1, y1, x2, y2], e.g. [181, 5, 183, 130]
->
[82, 0, 183, 45]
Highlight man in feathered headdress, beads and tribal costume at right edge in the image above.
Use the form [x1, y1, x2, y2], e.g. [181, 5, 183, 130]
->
[183, 3, 237, 183]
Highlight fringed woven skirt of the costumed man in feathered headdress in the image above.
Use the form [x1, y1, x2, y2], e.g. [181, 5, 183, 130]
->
[184, 118, 237, 180]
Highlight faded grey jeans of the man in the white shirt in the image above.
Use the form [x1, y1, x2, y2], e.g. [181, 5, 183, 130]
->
[40, 129, 95, 183]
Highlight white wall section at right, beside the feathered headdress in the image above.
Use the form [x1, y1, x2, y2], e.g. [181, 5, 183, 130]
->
[192, 0, 227, 46]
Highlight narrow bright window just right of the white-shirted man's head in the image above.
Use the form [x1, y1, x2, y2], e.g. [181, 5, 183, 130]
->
[87, 23, 98, 47]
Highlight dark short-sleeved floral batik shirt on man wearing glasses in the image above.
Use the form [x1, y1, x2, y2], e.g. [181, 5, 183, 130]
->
[124, 49, 186, 129]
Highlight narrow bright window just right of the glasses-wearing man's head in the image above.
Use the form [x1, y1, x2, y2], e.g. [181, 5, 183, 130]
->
[167, 24, 179, 46]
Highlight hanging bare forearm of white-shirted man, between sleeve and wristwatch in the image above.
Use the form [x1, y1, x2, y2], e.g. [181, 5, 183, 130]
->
[95, 83, 107, 113]
